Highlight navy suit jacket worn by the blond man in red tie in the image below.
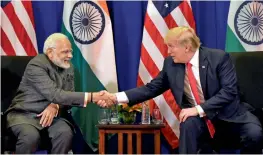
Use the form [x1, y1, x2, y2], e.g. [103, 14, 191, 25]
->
[125, 47, 258, 124]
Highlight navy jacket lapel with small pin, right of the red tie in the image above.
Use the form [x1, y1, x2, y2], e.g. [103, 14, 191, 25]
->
[199, 47, 208, 99]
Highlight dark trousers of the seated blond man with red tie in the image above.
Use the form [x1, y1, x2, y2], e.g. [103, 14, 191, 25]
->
[179, 116, 262, 154]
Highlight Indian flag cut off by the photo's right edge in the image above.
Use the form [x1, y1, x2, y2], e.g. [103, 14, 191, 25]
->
[225, 0, 263, 52]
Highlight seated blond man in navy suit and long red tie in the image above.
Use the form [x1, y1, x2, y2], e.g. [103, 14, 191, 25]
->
[99, 27, 262, 154]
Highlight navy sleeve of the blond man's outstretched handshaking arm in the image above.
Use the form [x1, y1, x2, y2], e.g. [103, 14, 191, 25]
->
[125, 60, 169, 106]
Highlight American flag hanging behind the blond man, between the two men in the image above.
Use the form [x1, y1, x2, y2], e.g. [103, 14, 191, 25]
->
[137, 0, 195, 148]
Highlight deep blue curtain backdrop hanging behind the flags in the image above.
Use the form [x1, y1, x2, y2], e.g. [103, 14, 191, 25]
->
[33, 1, 230, 153]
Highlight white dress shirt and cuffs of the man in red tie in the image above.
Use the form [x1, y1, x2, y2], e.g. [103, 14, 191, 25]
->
[115, 49, 205, 117]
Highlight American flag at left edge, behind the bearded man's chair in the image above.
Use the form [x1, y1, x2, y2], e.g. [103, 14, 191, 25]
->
[1, 1, 38, 56]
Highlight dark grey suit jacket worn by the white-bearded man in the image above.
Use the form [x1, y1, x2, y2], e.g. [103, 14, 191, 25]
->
[5, 54, 84, 129]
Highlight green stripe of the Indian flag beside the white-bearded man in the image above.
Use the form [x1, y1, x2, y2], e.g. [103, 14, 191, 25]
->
[62, 24, 105, 151]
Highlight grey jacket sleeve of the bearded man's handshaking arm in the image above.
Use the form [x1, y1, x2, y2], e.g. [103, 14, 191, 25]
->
[25, 62, 85, 106]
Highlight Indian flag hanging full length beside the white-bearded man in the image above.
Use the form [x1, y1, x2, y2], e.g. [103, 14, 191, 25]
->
[62, 1, 118, 150]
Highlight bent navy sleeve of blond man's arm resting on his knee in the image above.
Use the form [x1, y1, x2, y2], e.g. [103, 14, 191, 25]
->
[200, 53, 238, 119]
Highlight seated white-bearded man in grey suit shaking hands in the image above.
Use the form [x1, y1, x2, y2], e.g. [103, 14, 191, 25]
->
[5, 33, 111, 154]
